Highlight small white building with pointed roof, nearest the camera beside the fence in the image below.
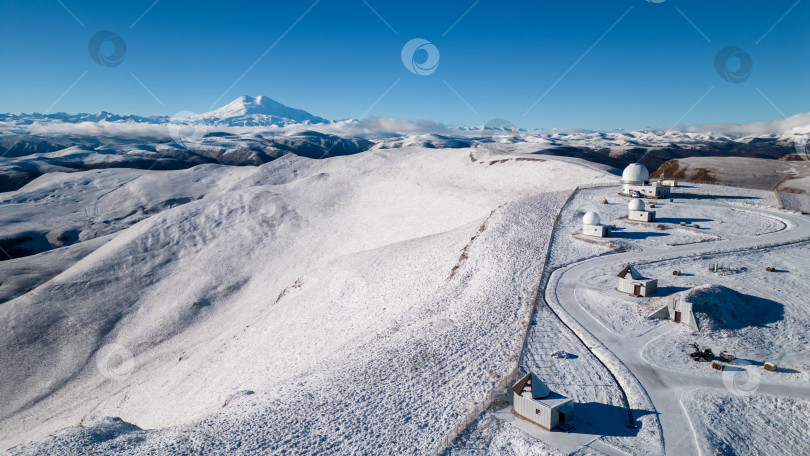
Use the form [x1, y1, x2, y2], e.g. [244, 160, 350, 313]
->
[512, 372, 574, 431]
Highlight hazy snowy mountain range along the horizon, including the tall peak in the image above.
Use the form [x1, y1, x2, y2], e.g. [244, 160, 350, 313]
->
[0, 95, 810, 149]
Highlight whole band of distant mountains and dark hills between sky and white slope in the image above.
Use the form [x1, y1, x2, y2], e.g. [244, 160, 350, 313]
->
[0, 95, 810, 195]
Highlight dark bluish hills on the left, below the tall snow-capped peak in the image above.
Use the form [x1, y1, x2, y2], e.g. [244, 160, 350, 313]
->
[0, 130, 373, 191]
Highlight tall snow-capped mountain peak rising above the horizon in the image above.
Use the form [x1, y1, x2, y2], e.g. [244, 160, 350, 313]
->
[198, 95, 328, 126]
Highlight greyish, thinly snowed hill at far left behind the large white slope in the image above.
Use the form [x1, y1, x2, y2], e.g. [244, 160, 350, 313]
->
[0, 165, 247, 276]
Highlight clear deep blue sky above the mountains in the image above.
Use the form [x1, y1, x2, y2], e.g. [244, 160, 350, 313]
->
[0, 0, 810, 129]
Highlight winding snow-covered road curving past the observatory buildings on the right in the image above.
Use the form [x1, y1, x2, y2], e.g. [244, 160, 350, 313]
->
[545, 200, 810, 455]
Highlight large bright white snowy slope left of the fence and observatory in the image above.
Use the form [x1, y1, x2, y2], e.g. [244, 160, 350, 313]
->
[0, 148, 615, 454]
